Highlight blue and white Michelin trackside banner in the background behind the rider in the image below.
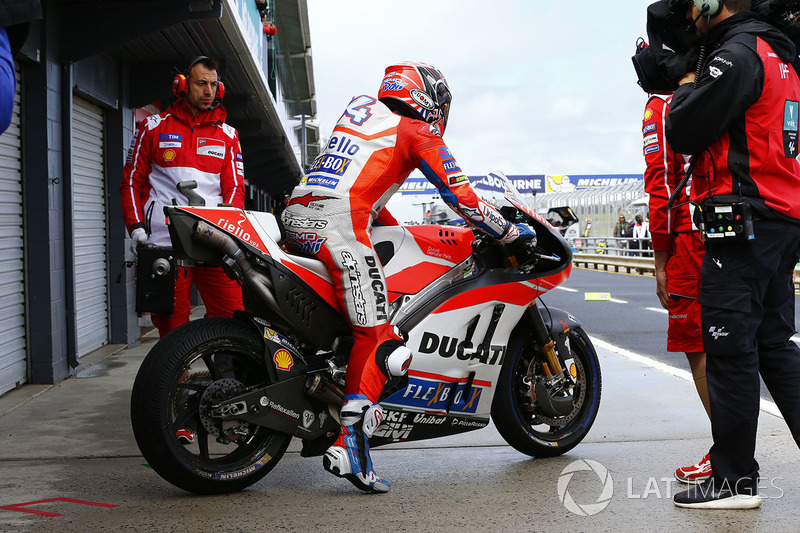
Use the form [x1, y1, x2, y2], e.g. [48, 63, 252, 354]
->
[400, 174, 644, 195]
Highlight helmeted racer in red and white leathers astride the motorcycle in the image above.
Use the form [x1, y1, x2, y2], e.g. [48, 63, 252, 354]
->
[282, 62, 535, 492]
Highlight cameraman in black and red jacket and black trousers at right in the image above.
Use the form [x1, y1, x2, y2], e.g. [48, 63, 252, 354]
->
[666, 0, 800, 509]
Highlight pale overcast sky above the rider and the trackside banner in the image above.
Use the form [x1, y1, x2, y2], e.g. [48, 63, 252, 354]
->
[308, 0, 651, 179]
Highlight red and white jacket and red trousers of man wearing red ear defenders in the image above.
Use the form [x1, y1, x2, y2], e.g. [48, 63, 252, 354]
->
[120, 99, 244, 336]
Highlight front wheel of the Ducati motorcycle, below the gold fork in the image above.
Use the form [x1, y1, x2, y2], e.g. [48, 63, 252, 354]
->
[492, 327, 602, 457]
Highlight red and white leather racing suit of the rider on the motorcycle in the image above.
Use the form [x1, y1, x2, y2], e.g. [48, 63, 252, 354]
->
[283, 95, 519, 403]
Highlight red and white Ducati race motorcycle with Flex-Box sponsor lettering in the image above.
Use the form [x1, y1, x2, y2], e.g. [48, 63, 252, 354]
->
[131, 176, 601, 494]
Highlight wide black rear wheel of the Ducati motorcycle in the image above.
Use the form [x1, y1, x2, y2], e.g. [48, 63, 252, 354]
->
[131, 318, 291, 494]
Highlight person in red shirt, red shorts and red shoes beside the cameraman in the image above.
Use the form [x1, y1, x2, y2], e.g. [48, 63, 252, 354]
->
[642, 94, 711, 483]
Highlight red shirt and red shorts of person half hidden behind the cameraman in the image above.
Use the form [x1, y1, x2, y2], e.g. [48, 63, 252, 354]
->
[642, 95, 705, 352]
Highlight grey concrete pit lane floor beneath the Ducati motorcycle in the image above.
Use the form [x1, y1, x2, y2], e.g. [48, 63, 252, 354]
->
[0, 330, 800, 532]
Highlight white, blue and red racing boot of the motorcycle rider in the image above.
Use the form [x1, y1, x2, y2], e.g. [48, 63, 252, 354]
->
[322, 394, 389, 492]
